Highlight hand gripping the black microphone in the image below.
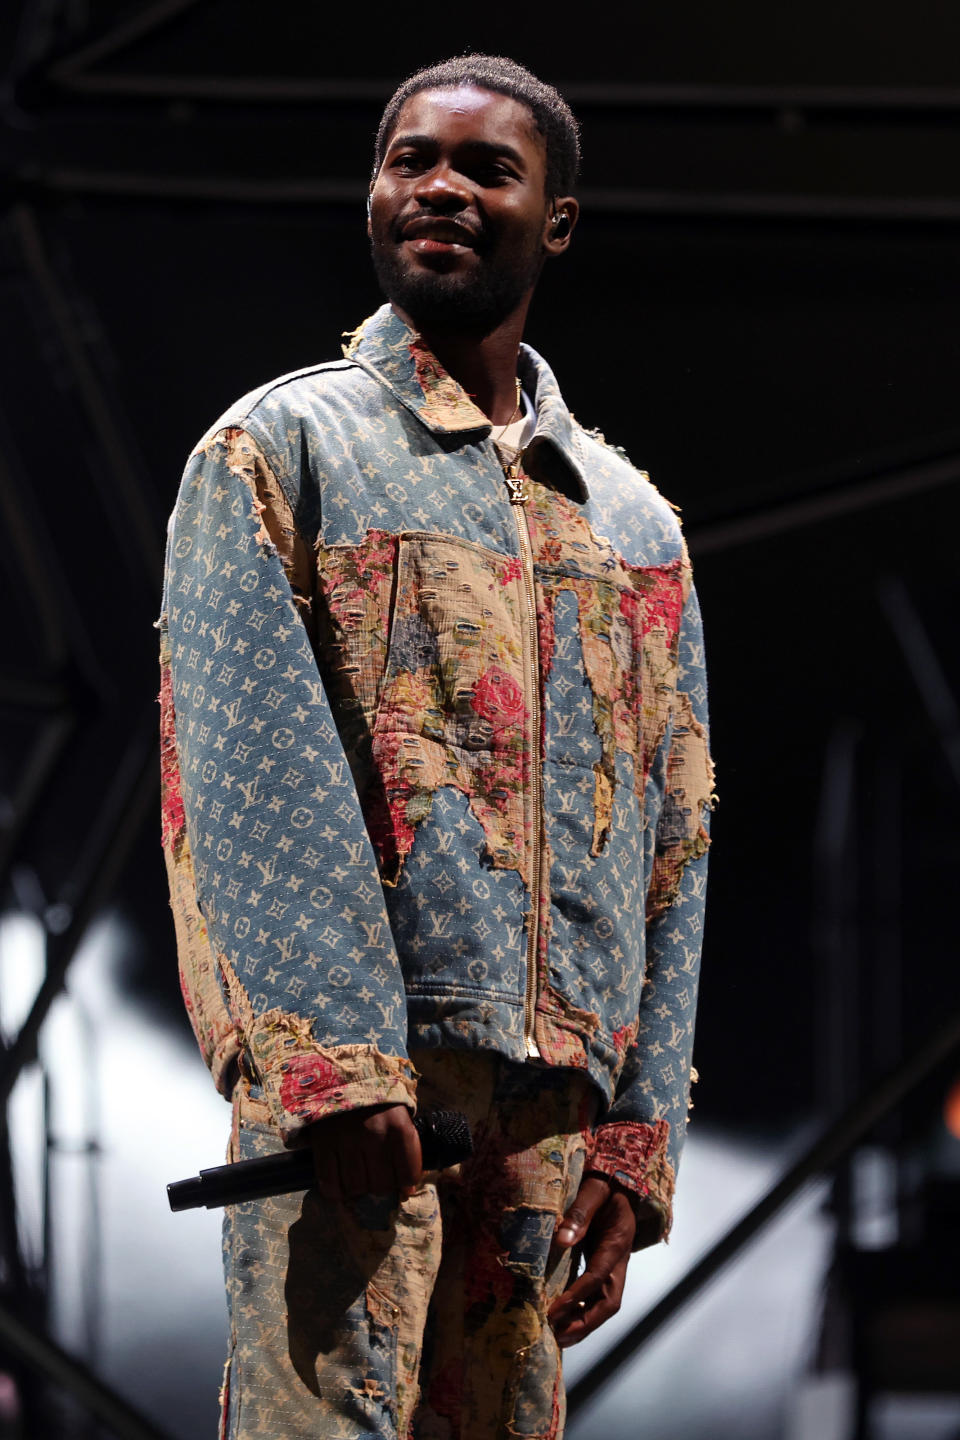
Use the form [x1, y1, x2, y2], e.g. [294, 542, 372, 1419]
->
[307, 1104, 423, 1200]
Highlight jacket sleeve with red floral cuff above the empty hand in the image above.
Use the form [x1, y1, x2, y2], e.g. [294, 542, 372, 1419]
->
[592, 589, 714, 1237]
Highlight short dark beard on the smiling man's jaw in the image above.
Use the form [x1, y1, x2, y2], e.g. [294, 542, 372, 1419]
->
[370, 224, 543, 338]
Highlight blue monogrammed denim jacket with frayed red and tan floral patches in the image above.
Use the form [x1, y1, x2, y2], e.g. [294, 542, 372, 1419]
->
[160, 305, 712, 1227]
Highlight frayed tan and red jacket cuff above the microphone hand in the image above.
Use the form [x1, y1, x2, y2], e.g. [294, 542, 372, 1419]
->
[245, 1031, 416, 1145]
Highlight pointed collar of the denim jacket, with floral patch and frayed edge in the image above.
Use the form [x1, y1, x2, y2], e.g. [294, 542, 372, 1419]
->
[344, 305, 587, 500]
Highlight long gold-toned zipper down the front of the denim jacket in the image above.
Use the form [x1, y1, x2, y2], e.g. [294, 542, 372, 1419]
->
[507, 471, 543, 1060]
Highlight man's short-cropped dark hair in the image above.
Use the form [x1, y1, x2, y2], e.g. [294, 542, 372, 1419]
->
[373, 55, 580, 196]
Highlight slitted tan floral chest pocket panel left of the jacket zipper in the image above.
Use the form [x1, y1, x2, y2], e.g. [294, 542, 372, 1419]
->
[367, 533, 531, 881]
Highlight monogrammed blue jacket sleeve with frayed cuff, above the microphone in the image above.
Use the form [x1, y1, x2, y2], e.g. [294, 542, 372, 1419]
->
[160, 429, 415, 1140]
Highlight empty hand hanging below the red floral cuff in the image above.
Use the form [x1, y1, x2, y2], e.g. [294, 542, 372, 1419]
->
[547, 1175, 636, 1348]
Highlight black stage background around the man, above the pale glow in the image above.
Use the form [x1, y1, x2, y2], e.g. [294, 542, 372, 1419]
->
[0, 0, 960, 1434]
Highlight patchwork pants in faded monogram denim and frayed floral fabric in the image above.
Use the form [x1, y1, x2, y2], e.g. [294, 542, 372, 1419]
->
[220, 1051, 594, 1440]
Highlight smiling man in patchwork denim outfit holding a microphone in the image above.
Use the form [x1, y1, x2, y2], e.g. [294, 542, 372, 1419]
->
[161, 56, 711, 1440]
